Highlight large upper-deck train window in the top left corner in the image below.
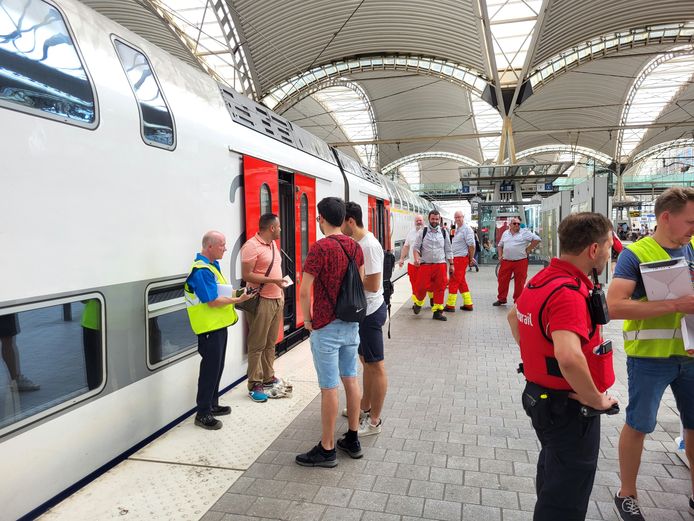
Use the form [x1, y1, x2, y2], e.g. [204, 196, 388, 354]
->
[0, 0, 96, 128]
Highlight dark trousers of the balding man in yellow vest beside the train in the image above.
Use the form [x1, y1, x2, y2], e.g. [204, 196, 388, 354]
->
[196, 328, 228, 416]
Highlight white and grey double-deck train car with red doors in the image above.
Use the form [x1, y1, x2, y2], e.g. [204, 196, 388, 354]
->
[0, 0, 430, 519]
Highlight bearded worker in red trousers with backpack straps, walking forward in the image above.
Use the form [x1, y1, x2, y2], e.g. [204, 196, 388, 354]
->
[412, 210, 454, 322]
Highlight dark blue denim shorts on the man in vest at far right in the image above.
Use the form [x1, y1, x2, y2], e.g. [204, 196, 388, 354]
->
[626, 356, 694, 434]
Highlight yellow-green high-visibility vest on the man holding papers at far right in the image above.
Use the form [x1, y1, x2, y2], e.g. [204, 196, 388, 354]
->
[622, 237, 687, 358]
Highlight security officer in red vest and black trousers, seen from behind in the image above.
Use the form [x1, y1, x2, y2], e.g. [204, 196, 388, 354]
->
[508, 212, 619, 521]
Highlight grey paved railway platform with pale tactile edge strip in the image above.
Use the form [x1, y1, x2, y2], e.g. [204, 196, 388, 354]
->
[43, 267, 691, 521]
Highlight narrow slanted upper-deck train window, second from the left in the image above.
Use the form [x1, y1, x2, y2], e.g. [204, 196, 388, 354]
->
[113, 39, 176, 150]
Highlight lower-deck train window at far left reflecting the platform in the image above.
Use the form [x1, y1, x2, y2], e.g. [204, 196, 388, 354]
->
[0, 298, 104, 429]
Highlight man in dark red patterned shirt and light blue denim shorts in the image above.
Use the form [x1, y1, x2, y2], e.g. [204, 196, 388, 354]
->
[296, 197, 364, 467]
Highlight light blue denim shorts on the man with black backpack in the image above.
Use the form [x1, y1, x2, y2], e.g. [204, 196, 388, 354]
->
[310, 319, 359, 389]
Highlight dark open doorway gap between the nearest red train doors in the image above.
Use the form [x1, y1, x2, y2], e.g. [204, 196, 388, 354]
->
[278, 170, 297, 338]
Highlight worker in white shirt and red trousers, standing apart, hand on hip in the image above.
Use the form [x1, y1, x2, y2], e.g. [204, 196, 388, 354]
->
[492, 217, 540, 306]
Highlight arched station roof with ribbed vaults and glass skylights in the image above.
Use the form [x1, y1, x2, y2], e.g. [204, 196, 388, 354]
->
[83, 0, 694, 187]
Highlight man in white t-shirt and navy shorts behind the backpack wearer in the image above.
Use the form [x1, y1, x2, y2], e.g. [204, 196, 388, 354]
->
[342, 201, 388, 436]
